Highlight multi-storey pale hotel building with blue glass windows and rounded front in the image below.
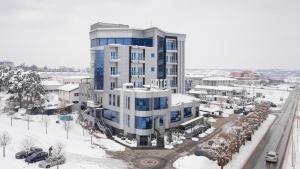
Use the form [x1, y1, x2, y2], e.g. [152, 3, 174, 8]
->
[85, 23, 198, 146]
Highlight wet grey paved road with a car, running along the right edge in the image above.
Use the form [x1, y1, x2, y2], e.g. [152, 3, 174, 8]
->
[244, 88, 300, 169]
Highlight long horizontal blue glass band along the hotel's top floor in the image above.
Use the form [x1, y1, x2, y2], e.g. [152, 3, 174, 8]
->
[91, 37, 153, 47]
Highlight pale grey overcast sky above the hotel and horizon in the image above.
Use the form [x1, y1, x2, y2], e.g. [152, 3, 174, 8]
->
[0, 0, 300, 69]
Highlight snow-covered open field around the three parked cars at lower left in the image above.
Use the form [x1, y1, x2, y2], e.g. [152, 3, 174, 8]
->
[0, 94, 127, 169]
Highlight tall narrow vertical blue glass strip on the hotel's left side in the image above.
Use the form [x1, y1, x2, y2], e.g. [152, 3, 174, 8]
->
[94, 50, 104, 90]
